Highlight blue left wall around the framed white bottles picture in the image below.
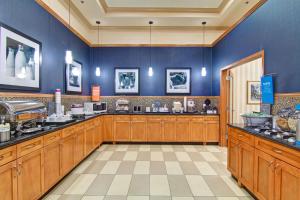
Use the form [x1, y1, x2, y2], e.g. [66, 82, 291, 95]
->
[0, 0, 90, 94]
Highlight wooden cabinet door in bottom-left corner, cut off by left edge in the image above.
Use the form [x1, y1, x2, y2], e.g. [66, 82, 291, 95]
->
[0, 161, 18, 200]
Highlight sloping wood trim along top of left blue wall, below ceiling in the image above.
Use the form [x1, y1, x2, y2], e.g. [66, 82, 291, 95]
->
[35, 0, 91, 46]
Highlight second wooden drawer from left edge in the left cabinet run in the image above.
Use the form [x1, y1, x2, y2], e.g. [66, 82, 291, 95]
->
[17, 137, 43, 158]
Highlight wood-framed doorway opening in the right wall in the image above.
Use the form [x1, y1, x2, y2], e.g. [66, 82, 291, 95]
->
[220, 50, 264, 146]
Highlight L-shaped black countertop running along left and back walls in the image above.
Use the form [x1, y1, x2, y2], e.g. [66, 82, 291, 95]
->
[0, 112, 219, 149]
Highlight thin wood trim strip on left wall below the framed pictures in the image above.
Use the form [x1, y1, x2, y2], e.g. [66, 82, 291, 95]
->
[0, 92, 91, 99]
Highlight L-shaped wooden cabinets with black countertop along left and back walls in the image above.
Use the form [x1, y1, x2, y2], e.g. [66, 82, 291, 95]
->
[0, 113, 219, 199]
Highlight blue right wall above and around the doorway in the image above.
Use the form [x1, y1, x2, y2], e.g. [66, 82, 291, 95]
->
[213, 0, 300, 95]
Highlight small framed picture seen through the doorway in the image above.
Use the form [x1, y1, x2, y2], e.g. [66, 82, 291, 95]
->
[247, 81, 261, 104]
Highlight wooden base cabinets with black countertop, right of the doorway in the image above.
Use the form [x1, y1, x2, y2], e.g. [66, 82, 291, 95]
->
[227, 124, 300, 200]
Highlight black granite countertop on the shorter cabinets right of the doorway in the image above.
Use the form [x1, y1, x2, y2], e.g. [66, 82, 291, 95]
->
[228, 124, 300, 151]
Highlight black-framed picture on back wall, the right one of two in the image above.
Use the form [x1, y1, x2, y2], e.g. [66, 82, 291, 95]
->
[166, 68, 191, 94]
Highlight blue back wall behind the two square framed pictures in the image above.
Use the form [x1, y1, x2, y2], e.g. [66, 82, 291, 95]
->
[91, 47, 212, 96]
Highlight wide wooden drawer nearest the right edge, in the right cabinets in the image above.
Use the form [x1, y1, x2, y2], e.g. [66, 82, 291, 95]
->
[255, 137, 300, 168]
